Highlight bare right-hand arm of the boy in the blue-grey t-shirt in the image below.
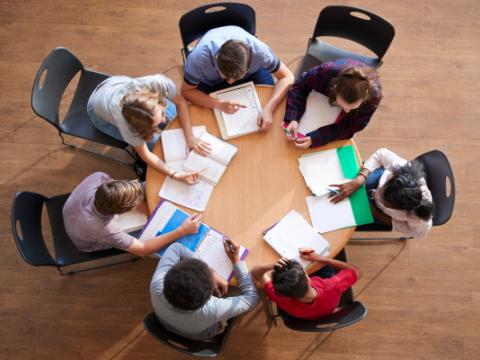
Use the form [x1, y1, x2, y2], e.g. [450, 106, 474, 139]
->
[258, 63, 294, 130]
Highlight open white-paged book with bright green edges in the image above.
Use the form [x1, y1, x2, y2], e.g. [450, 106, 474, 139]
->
[299, 145, 373, 233]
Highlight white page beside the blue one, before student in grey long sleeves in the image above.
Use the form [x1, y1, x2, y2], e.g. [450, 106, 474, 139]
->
[196, 229, 247, 281]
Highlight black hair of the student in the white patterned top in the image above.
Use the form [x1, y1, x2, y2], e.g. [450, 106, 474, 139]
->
[383, 160, 434, 220]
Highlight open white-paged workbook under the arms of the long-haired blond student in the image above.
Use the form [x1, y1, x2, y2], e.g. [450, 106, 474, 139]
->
[159, 126, 238, 211]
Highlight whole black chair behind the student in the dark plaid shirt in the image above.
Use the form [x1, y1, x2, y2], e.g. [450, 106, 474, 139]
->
[296, 6, 395, 78]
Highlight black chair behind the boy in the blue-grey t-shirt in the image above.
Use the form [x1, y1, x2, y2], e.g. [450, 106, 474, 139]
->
[178, 3, 256, 63]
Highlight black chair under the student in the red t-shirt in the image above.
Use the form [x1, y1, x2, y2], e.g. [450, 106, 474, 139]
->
[267, 249, 367, 332]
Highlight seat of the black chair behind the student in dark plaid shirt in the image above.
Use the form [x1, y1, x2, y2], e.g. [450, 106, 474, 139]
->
[297, 39, 380, 78]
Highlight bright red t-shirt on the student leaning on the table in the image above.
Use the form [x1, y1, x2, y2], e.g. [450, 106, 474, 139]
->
[264, 269, 357, 320]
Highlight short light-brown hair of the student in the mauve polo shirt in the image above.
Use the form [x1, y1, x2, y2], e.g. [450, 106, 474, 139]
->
[93, 180, 144, 215]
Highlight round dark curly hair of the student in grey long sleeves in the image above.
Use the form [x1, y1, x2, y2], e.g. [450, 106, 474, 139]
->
[163, 259, 213, 310]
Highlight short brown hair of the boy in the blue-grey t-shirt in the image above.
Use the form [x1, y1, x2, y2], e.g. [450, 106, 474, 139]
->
[216, 40, 252, 80]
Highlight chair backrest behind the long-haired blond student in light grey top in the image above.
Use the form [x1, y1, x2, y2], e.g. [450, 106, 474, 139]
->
[32, 47, 84, 130]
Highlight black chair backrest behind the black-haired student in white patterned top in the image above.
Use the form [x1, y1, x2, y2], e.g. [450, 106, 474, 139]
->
[416, 150, 455, 226]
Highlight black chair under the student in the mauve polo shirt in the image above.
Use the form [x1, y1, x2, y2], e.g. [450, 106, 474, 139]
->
[11, 191, 138, 275]
